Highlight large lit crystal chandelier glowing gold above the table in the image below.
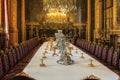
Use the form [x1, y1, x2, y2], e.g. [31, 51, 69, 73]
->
[43, 0, 76, 23]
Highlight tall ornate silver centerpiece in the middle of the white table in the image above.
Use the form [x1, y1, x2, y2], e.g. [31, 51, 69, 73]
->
[55, 30, 74, 65]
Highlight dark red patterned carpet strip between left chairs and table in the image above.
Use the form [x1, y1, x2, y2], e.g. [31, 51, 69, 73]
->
[0, 45, 40, 80]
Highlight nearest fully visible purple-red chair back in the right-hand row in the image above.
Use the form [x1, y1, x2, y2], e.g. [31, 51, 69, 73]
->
[112, 50, 120, 68]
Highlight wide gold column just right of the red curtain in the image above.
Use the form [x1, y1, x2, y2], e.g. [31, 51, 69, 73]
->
[8, 0, 18, 45]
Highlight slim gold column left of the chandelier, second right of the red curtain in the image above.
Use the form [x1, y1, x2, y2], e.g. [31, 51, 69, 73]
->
[21, 0, 26, 41]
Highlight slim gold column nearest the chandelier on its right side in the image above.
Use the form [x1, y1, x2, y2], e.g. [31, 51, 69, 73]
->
[87, 0, 91, 41]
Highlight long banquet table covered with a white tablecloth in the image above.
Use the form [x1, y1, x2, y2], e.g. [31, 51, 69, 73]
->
[23, 42, 119, 80]
